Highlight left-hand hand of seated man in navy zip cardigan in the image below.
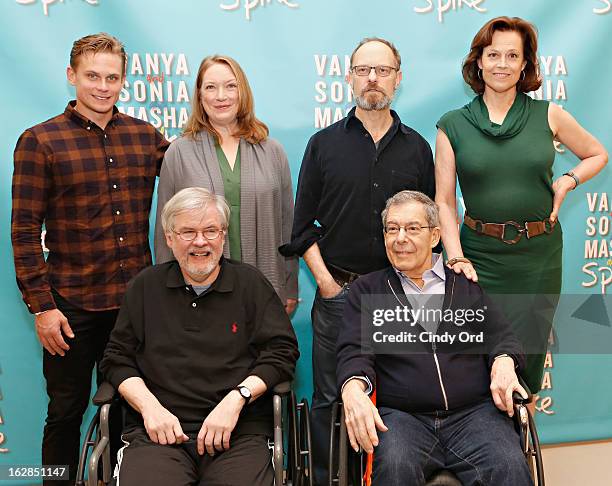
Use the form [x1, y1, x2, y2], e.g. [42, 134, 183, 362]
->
[342, 379, 388, 454]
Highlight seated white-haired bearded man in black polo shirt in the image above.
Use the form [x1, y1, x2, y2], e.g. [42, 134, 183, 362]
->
[101, 188, 299, 486]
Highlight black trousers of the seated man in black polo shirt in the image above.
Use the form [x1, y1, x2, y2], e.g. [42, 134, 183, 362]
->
[117, 429, 274, 486]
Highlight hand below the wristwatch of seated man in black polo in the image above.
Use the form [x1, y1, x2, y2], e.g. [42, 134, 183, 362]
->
[198, 390, 246, 456]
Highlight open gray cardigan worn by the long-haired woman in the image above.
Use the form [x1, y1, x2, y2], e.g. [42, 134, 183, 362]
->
[155, 132, 298, 303]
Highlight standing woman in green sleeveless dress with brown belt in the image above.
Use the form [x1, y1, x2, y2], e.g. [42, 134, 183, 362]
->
[436, 17, 608, 392]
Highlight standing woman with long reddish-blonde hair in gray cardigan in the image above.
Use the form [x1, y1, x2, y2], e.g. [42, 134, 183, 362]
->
[155, 55, 298, 313]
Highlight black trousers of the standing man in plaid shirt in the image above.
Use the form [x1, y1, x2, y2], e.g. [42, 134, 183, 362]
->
[42, 292, 120, 486]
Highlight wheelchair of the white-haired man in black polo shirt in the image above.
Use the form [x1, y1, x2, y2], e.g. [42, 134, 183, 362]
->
[75, 382, 312, 486]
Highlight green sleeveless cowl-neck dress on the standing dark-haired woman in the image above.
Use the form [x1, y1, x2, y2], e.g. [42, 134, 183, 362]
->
[437, 93, 563, 393]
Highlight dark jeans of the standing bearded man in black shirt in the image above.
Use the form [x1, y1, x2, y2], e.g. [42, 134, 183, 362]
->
[310, 286, 349, 486]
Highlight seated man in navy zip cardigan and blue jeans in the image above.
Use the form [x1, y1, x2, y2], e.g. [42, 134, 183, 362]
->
[337, 191, 532, 486]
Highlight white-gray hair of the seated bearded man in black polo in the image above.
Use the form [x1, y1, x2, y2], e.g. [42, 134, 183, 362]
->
[161, 187, 230, 233]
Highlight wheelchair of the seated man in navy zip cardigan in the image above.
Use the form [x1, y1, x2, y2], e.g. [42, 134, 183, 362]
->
[329, 390, 545, 486]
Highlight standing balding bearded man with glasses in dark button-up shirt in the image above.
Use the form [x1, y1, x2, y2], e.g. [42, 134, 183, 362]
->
[281, 38, 435, 485]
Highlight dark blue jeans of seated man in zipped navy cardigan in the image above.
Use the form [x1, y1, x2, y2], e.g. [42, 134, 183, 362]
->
[372, 401, 533, 486]
